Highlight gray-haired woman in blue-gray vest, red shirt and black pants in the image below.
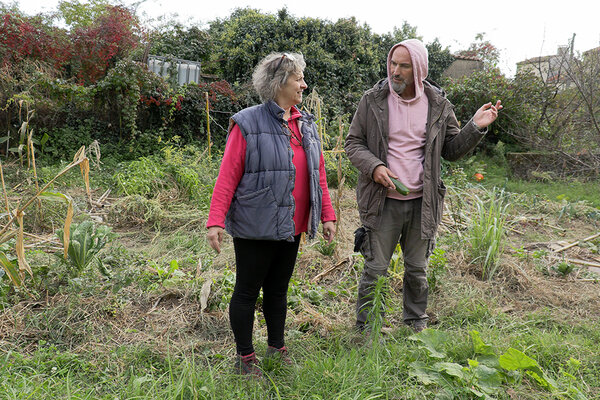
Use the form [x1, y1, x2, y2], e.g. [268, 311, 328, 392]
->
[206, 53, 335, 376]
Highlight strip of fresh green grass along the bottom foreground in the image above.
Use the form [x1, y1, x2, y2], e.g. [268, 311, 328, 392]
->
[0, 320, 600, 400]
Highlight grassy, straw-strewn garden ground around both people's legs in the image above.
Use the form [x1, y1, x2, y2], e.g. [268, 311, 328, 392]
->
[0, 151, 600, 400]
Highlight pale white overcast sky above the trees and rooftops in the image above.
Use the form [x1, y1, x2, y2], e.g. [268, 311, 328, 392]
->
[12, 0, 600, 76]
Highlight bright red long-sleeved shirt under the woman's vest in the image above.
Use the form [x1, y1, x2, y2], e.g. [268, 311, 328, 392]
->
[206, 107, 336, 235]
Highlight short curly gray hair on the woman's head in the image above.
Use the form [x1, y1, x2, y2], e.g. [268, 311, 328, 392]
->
[252, 53, 306, 102]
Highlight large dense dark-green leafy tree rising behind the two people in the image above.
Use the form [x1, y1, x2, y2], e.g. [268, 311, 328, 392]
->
[208, 8, 449, 121]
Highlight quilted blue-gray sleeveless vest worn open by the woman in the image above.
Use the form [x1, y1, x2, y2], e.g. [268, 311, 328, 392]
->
[225, 101, 323, 241]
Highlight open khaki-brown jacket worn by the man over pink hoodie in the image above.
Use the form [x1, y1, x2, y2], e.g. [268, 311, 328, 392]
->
[345, 79, 486, 239]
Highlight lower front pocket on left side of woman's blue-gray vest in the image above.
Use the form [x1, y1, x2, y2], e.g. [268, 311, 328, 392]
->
[230, 187, 278, 239]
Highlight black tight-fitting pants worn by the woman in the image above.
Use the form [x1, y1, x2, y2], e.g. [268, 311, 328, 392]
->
[229, 235, 300, 355]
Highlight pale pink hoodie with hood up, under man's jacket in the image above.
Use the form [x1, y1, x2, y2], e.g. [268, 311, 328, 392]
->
[387, 39, 429, 200]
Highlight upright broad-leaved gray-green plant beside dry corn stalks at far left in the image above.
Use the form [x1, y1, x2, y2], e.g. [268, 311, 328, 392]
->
[56, 221, 116, 276]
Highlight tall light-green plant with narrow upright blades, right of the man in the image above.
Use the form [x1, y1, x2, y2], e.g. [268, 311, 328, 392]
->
[469, 189, 510, 280]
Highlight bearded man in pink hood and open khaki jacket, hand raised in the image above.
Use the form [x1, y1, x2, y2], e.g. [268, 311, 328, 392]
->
[345, 39, 502, 332]
